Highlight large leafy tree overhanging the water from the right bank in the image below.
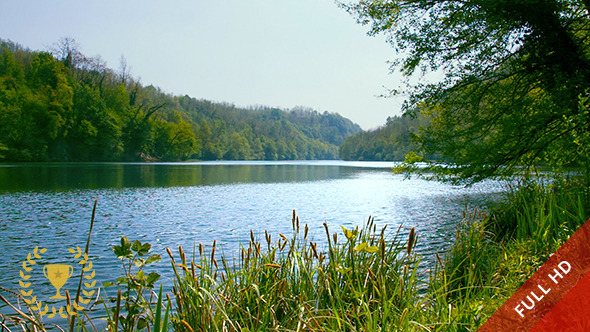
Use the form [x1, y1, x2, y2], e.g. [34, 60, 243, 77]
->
[342, 0, 590, 182]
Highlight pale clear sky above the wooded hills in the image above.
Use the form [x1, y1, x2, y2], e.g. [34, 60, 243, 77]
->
[0, 0, 403, 129]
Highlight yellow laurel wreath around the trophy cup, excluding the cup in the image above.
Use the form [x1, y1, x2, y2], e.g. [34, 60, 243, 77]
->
[18, 247, 96, 318]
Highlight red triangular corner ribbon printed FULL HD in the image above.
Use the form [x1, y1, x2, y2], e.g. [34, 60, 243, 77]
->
[478, 219, 590, 332]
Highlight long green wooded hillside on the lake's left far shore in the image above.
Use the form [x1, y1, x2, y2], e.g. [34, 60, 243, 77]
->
[0, 39, 360, 161]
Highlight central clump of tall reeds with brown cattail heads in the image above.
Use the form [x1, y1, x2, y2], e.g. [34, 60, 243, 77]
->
[169, 212, 420, 331]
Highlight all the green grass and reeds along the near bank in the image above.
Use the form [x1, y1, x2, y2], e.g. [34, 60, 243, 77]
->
[0, 179, 590, 332]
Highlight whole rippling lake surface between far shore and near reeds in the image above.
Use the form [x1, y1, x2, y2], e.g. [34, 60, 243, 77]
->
[0, 161, 505, 320]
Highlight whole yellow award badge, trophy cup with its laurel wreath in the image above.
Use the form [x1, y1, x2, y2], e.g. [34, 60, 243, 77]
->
[19, 247, 96, 318]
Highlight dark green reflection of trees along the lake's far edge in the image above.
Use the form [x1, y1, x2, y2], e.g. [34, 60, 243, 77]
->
[0, 162, 380, 192]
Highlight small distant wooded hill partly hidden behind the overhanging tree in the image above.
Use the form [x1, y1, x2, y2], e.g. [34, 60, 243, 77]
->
[339, 115, 437, 161]
